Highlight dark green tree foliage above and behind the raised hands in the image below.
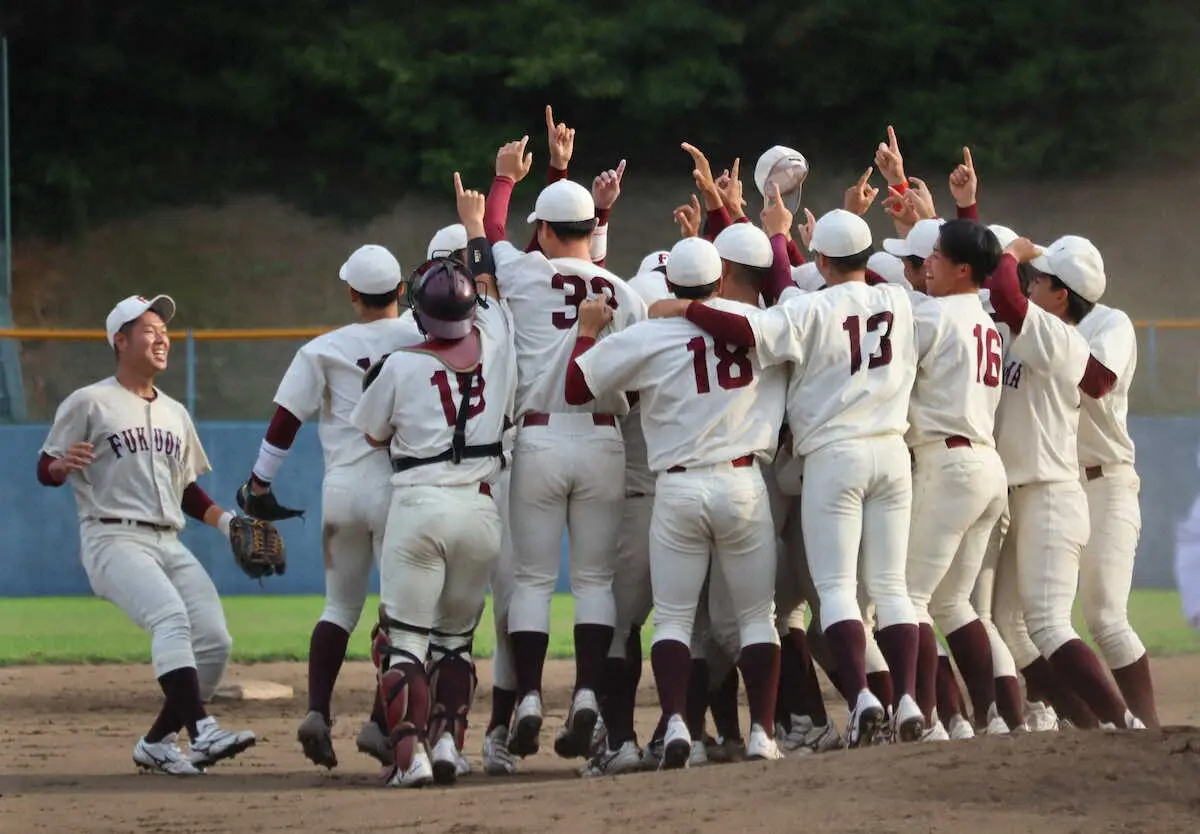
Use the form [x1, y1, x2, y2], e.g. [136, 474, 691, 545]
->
[9, 0, 1200, 234]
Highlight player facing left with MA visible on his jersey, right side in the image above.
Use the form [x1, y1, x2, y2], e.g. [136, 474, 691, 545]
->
[986, 235, 1144, 728]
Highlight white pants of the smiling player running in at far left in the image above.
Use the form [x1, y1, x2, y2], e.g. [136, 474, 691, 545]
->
[79, 521, 233, 701]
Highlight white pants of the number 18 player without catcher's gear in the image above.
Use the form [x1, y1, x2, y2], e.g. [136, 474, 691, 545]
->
[650, 463, 779, 648]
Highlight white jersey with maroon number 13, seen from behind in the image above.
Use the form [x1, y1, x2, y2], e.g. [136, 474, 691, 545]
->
[749, 281, 917, 457]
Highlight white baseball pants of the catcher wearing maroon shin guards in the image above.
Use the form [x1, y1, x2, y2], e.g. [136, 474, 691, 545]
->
[379, 485, 500, 660]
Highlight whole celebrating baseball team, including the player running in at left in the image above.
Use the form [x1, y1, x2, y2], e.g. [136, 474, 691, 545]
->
[38, 107, 1158, 787]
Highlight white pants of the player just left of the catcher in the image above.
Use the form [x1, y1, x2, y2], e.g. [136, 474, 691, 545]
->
[320, 470, 391, 631]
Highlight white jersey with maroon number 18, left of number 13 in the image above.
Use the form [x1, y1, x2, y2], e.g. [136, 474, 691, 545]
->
[577, 299, 787, 473]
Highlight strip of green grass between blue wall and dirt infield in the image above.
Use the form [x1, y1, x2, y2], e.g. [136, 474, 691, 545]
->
[0, 590, 1200, 666]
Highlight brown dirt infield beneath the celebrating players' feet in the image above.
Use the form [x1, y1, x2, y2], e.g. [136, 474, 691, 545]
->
[0, 658, 1200, 834]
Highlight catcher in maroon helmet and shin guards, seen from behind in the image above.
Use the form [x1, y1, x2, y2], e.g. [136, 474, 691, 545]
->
[350, 174, 516, 787]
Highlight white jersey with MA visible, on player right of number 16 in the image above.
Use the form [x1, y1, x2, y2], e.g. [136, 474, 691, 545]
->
[996, 304, 1088, 486]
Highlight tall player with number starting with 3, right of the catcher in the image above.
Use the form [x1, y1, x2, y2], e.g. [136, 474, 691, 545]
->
[485, 137, 646, 757]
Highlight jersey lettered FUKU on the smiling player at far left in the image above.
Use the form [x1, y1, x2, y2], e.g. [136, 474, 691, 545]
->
[42, 377, 212, 530]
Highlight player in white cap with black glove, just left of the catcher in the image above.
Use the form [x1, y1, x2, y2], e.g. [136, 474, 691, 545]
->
[239, 241, 422, 768]
